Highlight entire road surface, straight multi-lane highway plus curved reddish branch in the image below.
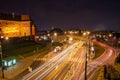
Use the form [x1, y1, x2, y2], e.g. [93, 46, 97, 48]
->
[22, 41, 115, 80]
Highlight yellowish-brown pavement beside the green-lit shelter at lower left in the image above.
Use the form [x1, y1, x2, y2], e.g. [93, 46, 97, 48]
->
[0, 56, 34, 80]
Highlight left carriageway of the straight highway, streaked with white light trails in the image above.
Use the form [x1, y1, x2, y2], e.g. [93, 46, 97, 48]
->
[22, 42, 84, 80]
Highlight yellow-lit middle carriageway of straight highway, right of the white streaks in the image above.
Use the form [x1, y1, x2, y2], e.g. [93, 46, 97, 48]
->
[43, 42, 85, 80]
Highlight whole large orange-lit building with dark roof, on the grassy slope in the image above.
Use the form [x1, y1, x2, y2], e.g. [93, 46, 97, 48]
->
[0, 13, 35, 38]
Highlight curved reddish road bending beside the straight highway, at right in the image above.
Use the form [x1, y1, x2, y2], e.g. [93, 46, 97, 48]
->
[76, 41, 116, 80]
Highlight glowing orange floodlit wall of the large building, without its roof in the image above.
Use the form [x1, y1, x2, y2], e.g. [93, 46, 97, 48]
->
[0, 20, 31, 37]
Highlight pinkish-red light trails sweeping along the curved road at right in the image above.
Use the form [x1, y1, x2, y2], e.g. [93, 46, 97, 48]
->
[79, 43, 115, 80]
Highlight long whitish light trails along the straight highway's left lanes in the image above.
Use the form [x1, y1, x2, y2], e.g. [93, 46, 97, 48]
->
[22, 43, 79, 80]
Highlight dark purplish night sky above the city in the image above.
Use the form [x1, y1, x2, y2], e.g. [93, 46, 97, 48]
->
[0, 0, 120, 31]
